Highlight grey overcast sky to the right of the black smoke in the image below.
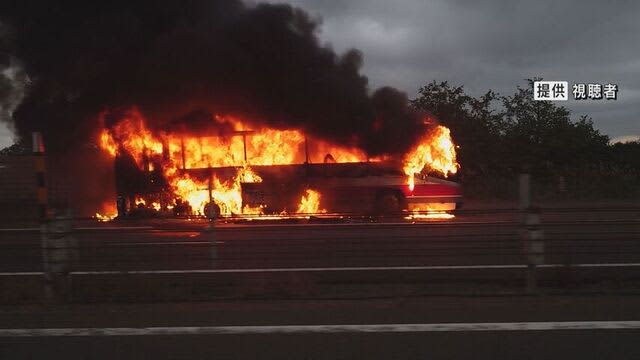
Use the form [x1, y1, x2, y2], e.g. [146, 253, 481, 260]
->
[0, 0, 640, 147]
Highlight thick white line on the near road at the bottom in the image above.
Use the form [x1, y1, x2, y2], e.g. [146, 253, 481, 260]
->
[0, 321, 640, 337]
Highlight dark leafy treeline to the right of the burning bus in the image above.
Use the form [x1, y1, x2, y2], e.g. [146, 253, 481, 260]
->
[412, 80, 640, 199]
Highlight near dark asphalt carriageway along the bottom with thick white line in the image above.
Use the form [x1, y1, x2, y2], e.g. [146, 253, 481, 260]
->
[0, 296, 640, 359]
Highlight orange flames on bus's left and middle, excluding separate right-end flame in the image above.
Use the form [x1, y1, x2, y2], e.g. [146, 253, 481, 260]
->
[96, 109, 368, 218]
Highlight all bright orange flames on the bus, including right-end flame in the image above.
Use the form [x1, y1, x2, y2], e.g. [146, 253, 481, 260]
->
[96, 109, 458, 219]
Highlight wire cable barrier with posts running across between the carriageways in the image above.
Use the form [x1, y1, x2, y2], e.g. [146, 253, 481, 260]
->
[0, 208, 640, 301]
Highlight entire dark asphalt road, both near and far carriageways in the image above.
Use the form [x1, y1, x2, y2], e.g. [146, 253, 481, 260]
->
[0, 211, 640, 359]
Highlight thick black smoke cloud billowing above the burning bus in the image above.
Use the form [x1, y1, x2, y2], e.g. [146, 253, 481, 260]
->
[0, 0, 428, 155]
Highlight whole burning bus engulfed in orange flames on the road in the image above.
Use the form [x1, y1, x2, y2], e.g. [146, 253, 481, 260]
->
[98, 110, 461, 219]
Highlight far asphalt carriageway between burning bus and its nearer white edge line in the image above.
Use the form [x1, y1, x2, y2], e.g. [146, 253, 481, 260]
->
[0, 212, 640, 272]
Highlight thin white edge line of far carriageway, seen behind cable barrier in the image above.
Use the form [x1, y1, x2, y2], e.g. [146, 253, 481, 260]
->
[0, 263, 640, 276]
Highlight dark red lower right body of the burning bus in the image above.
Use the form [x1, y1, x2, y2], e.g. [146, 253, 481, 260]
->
[242, 163, 462, 215]
